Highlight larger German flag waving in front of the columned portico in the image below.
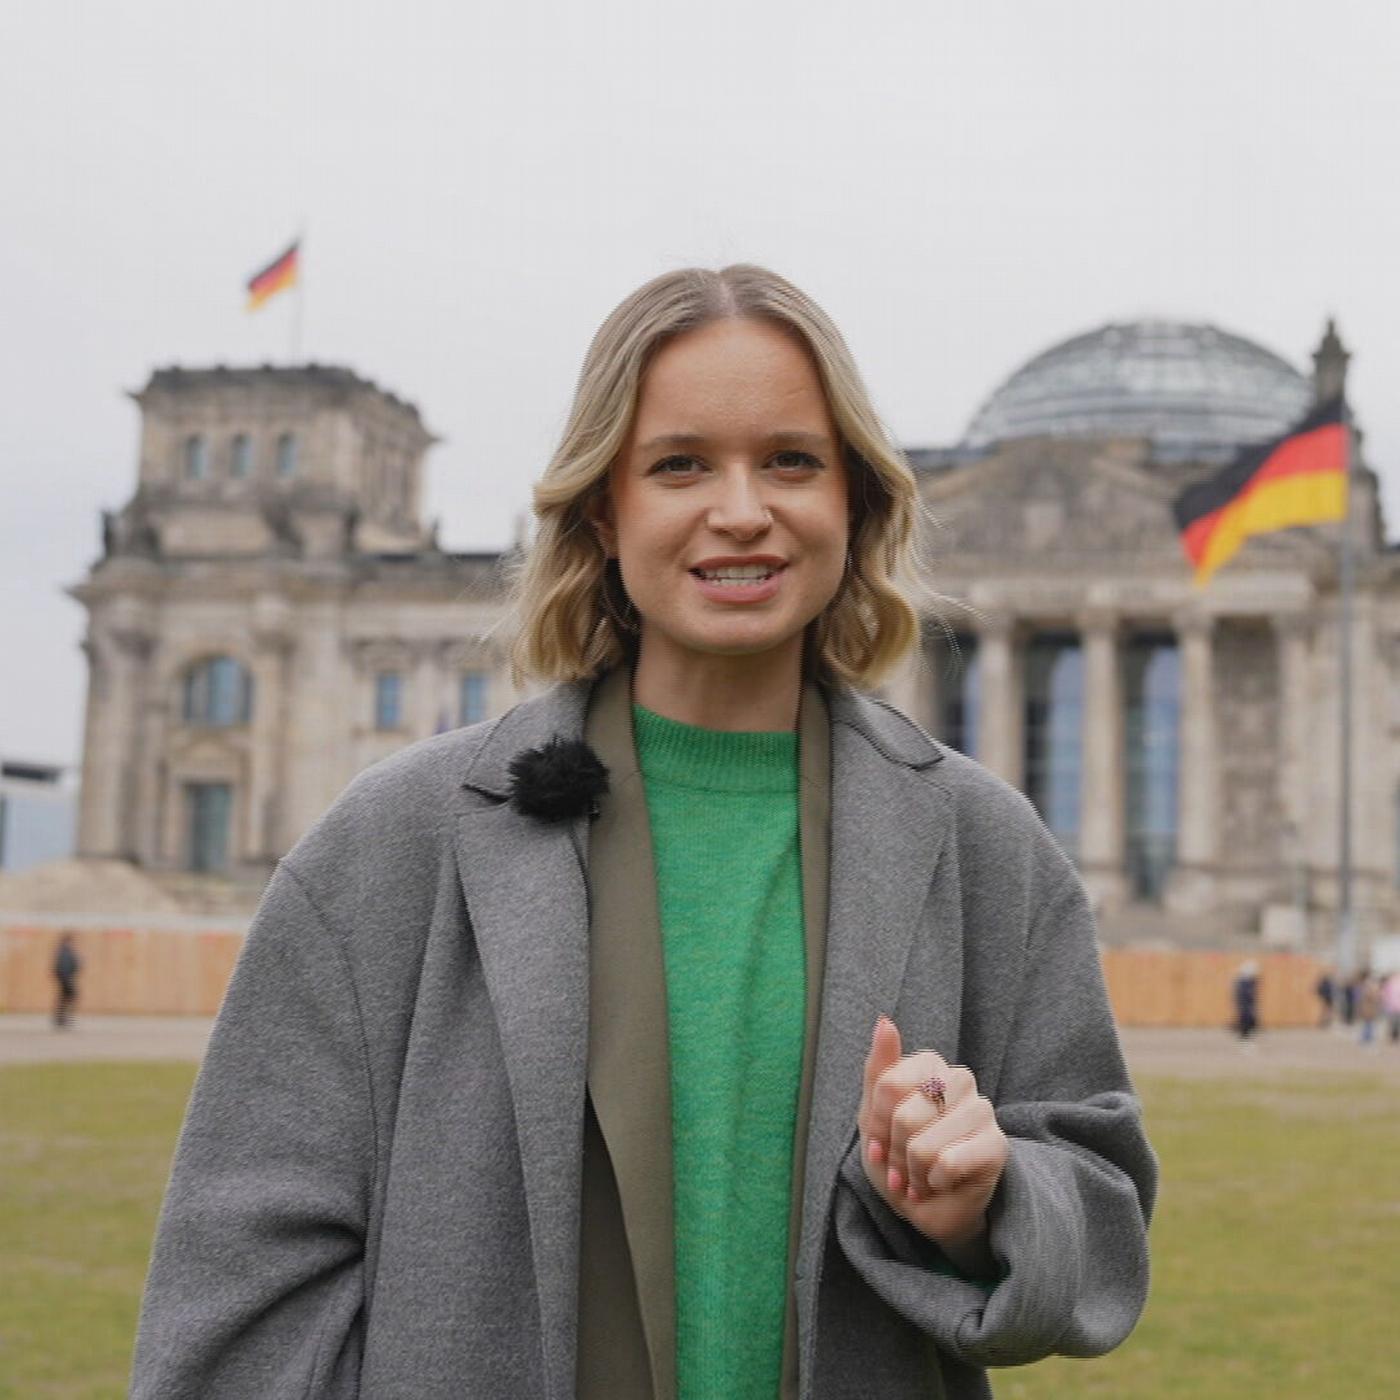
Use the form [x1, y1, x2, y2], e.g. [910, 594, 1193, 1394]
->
[1173, 399, 1348, 584]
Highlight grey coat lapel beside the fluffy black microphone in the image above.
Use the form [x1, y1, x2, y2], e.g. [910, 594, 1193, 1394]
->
[456, 686, 588, 1400]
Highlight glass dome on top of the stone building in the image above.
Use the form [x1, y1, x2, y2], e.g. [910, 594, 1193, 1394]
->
[963, 321, 1312, 461]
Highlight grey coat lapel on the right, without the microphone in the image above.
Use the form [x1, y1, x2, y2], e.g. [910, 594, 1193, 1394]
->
[797, 690, 958, 1336]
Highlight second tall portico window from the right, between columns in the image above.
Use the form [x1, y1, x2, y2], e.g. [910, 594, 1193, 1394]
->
[1025, 636, 1084, 855]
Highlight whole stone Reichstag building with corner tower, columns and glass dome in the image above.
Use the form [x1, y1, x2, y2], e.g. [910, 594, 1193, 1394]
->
[73, 321, 1400, 948]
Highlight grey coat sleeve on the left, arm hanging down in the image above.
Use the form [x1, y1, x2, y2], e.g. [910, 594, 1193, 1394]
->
[130, 862, 375, 1400]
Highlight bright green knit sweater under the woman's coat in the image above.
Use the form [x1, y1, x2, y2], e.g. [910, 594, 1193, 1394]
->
[634, 706, 806, 1400]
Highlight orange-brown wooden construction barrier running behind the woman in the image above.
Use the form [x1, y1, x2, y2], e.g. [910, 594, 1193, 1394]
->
[0, 920, 1323, 1029]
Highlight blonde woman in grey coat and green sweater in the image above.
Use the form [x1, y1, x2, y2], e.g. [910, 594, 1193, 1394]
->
[134, 266, 1155, 1400]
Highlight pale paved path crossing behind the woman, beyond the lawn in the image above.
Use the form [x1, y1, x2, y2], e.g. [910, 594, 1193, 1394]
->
[0, 1015, 1400, 1081]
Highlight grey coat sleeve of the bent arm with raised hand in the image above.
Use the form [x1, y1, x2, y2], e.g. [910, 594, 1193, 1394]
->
[836, 871, 1156, 1366]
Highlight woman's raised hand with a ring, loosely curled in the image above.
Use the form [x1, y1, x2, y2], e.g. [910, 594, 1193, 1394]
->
[857, 1016, 1007, 1274]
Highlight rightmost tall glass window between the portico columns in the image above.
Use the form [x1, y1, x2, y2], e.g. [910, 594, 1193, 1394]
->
[1123, 637, 1182, 900]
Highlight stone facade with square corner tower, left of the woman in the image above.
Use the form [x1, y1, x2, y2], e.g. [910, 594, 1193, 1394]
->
[74, 365, 517, 881]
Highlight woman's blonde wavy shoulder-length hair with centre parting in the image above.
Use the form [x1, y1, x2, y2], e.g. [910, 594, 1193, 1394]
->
[511, 263, 918, 686]
